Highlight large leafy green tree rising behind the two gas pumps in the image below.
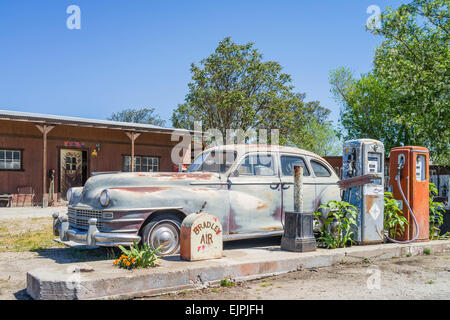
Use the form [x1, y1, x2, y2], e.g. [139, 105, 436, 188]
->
[330, 0, 450, 164]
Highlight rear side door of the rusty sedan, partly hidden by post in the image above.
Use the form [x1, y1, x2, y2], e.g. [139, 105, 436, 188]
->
[280, 153, 316, 212]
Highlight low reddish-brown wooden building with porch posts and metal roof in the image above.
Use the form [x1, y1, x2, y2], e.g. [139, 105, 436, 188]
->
[0, 110, 190, 206]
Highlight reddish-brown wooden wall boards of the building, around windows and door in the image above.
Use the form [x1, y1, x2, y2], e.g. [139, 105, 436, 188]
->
[0, 120, 182, 202]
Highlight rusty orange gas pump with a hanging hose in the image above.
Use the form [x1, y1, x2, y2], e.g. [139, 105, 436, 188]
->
[389, 146, 430, 243]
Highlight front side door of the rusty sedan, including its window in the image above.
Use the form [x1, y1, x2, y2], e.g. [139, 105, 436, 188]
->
[228, 152, 282, 234]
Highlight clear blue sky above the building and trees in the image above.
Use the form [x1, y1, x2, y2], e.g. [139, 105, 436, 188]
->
[0, 0, 406, 126]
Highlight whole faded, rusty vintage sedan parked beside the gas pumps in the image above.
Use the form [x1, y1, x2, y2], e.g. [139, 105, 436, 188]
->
[53, 145, 340, 254]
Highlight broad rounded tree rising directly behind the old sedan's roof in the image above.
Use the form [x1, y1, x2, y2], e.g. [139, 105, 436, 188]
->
[172, 37, 338, 155]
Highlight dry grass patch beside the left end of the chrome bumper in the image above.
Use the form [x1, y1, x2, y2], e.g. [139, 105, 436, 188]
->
[0, 218, 64, 252]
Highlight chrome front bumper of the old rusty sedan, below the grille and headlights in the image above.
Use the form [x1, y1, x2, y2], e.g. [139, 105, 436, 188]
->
[53, 213, 141, 247]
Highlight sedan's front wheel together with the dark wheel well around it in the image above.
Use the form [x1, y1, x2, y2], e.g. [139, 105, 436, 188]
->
[142, 214, 182, 255]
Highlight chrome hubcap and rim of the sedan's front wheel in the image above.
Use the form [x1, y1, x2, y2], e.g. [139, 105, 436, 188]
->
[149, 221, 179, 255]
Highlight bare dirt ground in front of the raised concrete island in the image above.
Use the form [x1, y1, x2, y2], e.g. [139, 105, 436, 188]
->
[144, 253, 450, 300]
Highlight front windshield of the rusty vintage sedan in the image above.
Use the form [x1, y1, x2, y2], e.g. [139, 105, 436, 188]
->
[188, 150, 236, 173]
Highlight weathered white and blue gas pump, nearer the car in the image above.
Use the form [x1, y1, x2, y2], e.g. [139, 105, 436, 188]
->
[339, 139, 384, 244]
